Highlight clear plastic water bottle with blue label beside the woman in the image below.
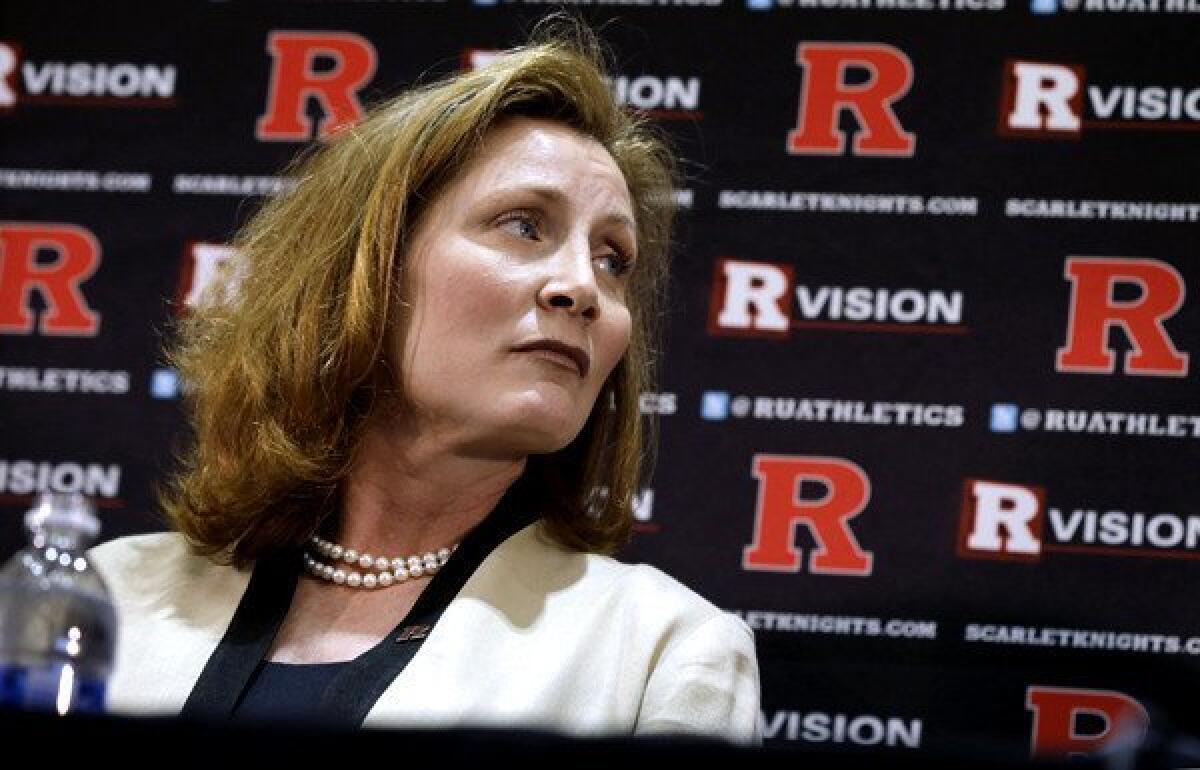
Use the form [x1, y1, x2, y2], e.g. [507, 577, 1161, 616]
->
[0, 493, 116, 714]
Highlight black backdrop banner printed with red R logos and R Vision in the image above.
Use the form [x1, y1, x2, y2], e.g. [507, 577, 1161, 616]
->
[0, 0, 1200, 756]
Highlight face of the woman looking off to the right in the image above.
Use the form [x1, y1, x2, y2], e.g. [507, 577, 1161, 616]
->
[394, 118, 637, 457]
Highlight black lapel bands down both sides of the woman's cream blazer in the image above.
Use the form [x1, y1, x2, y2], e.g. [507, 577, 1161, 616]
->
[181, 491, 538, 728]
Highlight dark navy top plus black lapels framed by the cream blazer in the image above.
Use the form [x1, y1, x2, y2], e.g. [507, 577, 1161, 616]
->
[181, 485, 539, 728]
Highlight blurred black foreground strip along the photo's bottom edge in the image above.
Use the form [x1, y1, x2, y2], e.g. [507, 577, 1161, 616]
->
[0, 710, 1200, 770]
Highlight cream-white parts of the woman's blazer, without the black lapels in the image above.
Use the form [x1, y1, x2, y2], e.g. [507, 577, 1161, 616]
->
[91, 523, 762, 744]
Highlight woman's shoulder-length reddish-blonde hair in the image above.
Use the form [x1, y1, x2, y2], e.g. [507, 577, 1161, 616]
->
[160, 24, 676, 566]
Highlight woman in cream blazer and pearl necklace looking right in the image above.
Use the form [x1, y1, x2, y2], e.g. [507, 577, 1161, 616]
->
[94, 25, 760, 742]
